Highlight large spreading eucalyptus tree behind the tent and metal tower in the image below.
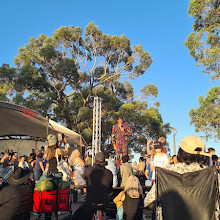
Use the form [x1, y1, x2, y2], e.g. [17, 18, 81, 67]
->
[0, 22, 170, 151]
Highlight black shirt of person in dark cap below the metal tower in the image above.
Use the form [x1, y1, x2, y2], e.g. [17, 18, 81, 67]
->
[83, 164, 113, 204]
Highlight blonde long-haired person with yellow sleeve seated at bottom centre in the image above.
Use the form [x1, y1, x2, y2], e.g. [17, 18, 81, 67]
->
[113, 175, 143, 220]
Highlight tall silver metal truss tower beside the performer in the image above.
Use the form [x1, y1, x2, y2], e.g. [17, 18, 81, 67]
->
[92, 97, 102, 164]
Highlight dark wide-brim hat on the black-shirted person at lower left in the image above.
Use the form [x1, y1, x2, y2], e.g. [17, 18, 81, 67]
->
[8, 167, 31, 185]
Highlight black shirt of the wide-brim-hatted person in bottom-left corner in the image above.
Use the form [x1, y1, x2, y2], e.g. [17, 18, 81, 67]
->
[0, 182, 34, 220]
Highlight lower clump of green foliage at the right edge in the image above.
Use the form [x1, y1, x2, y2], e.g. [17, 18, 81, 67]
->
[190, 87, 220, 140]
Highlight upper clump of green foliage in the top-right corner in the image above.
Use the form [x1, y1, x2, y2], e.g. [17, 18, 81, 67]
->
[185, 0, 220, 80]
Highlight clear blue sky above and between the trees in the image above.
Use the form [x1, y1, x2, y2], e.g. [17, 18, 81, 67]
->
[0, 0, 220, 155]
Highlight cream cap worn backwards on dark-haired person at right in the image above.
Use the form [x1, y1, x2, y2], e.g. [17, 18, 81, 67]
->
[179, 136, 210, 157]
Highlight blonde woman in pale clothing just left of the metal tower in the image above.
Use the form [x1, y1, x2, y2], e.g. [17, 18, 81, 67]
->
[68, 149, 86, 185]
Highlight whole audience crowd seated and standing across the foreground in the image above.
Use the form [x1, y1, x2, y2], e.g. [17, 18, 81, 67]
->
[0, 134, 219, 220]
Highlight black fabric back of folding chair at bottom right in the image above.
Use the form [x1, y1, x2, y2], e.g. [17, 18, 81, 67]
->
[156, 167, 219, 220]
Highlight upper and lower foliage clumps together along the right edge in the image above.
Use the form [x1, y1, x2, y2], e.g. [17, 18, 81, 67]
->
[185, 0, 220, 139]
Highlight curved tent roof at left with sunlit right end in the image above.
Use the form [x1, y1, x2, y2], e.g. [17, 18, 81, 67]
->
[0, 101, 82, 146]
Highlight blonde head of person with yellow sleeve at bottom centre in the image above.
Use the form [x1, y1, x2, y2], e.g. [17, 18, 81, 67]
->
[124, 175, 143, 197]
